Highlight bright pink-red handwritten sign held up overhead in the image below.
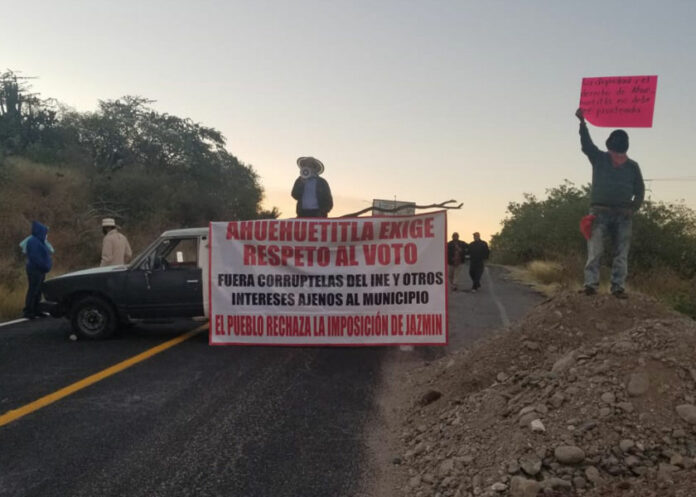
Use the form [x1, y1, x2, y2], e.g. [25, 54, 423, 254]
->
[580, 76, 657, 128]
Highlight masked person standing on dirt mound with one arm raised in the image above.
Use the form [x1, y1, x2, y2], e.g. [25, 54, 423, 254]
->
[575, 109, 645, 299]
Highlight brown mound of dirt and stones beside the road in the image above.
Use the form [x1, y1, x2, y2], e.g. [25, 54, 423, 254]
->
[396, 293, 696, 497]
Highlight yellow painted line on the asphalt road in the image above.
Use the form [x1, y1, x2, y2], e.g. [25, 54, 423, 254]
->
[0, 324, 208, 426]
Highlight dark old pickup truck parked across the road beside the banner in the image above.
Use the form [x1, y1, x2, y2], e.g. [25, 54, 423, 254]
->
[41, 228, 208, 340]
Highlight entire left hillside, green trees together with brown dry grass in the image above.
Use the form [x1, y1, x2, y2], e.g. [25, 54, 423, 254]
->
[0, 71, 279, 288]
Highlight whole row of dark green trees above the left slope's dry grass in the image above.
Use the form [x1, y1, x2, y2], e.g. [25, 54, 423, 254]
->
[0, 71, 275, 227]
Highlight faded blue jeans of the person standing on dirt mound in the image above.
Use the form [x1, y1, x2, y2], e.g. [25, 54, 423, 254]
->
[585, 209, 633, 292]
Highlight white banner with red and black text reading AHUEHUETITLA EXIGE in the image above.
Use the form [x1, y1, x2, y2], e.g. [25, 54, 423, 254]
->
[209, 211, 448, 346]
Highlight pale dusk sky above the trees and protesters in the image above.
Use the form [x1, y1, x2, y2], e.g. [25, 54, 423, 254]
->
[0, 0, 696, 241]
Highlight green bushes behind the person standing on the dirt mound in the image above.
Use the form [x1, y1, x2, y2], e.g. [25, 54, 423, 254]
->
[491, 182, 696, 317]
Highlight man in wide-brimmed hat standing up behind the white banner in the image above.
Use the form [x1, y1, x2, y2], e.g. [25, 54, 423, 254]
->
[292, 157, 333, 217]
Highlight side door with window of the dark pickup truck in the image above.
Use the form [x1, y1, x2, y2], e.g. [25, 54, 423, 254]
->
[127, 237, 204, 318]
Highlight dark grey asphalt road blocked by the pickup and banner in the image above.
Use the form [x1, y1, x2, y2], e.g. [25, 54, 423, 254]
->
[0, 268, 541, 497]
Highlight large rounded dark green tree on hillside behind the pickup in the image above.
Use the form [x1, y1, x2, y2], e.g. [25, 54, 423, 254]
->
[70, 96, 270, 226]
